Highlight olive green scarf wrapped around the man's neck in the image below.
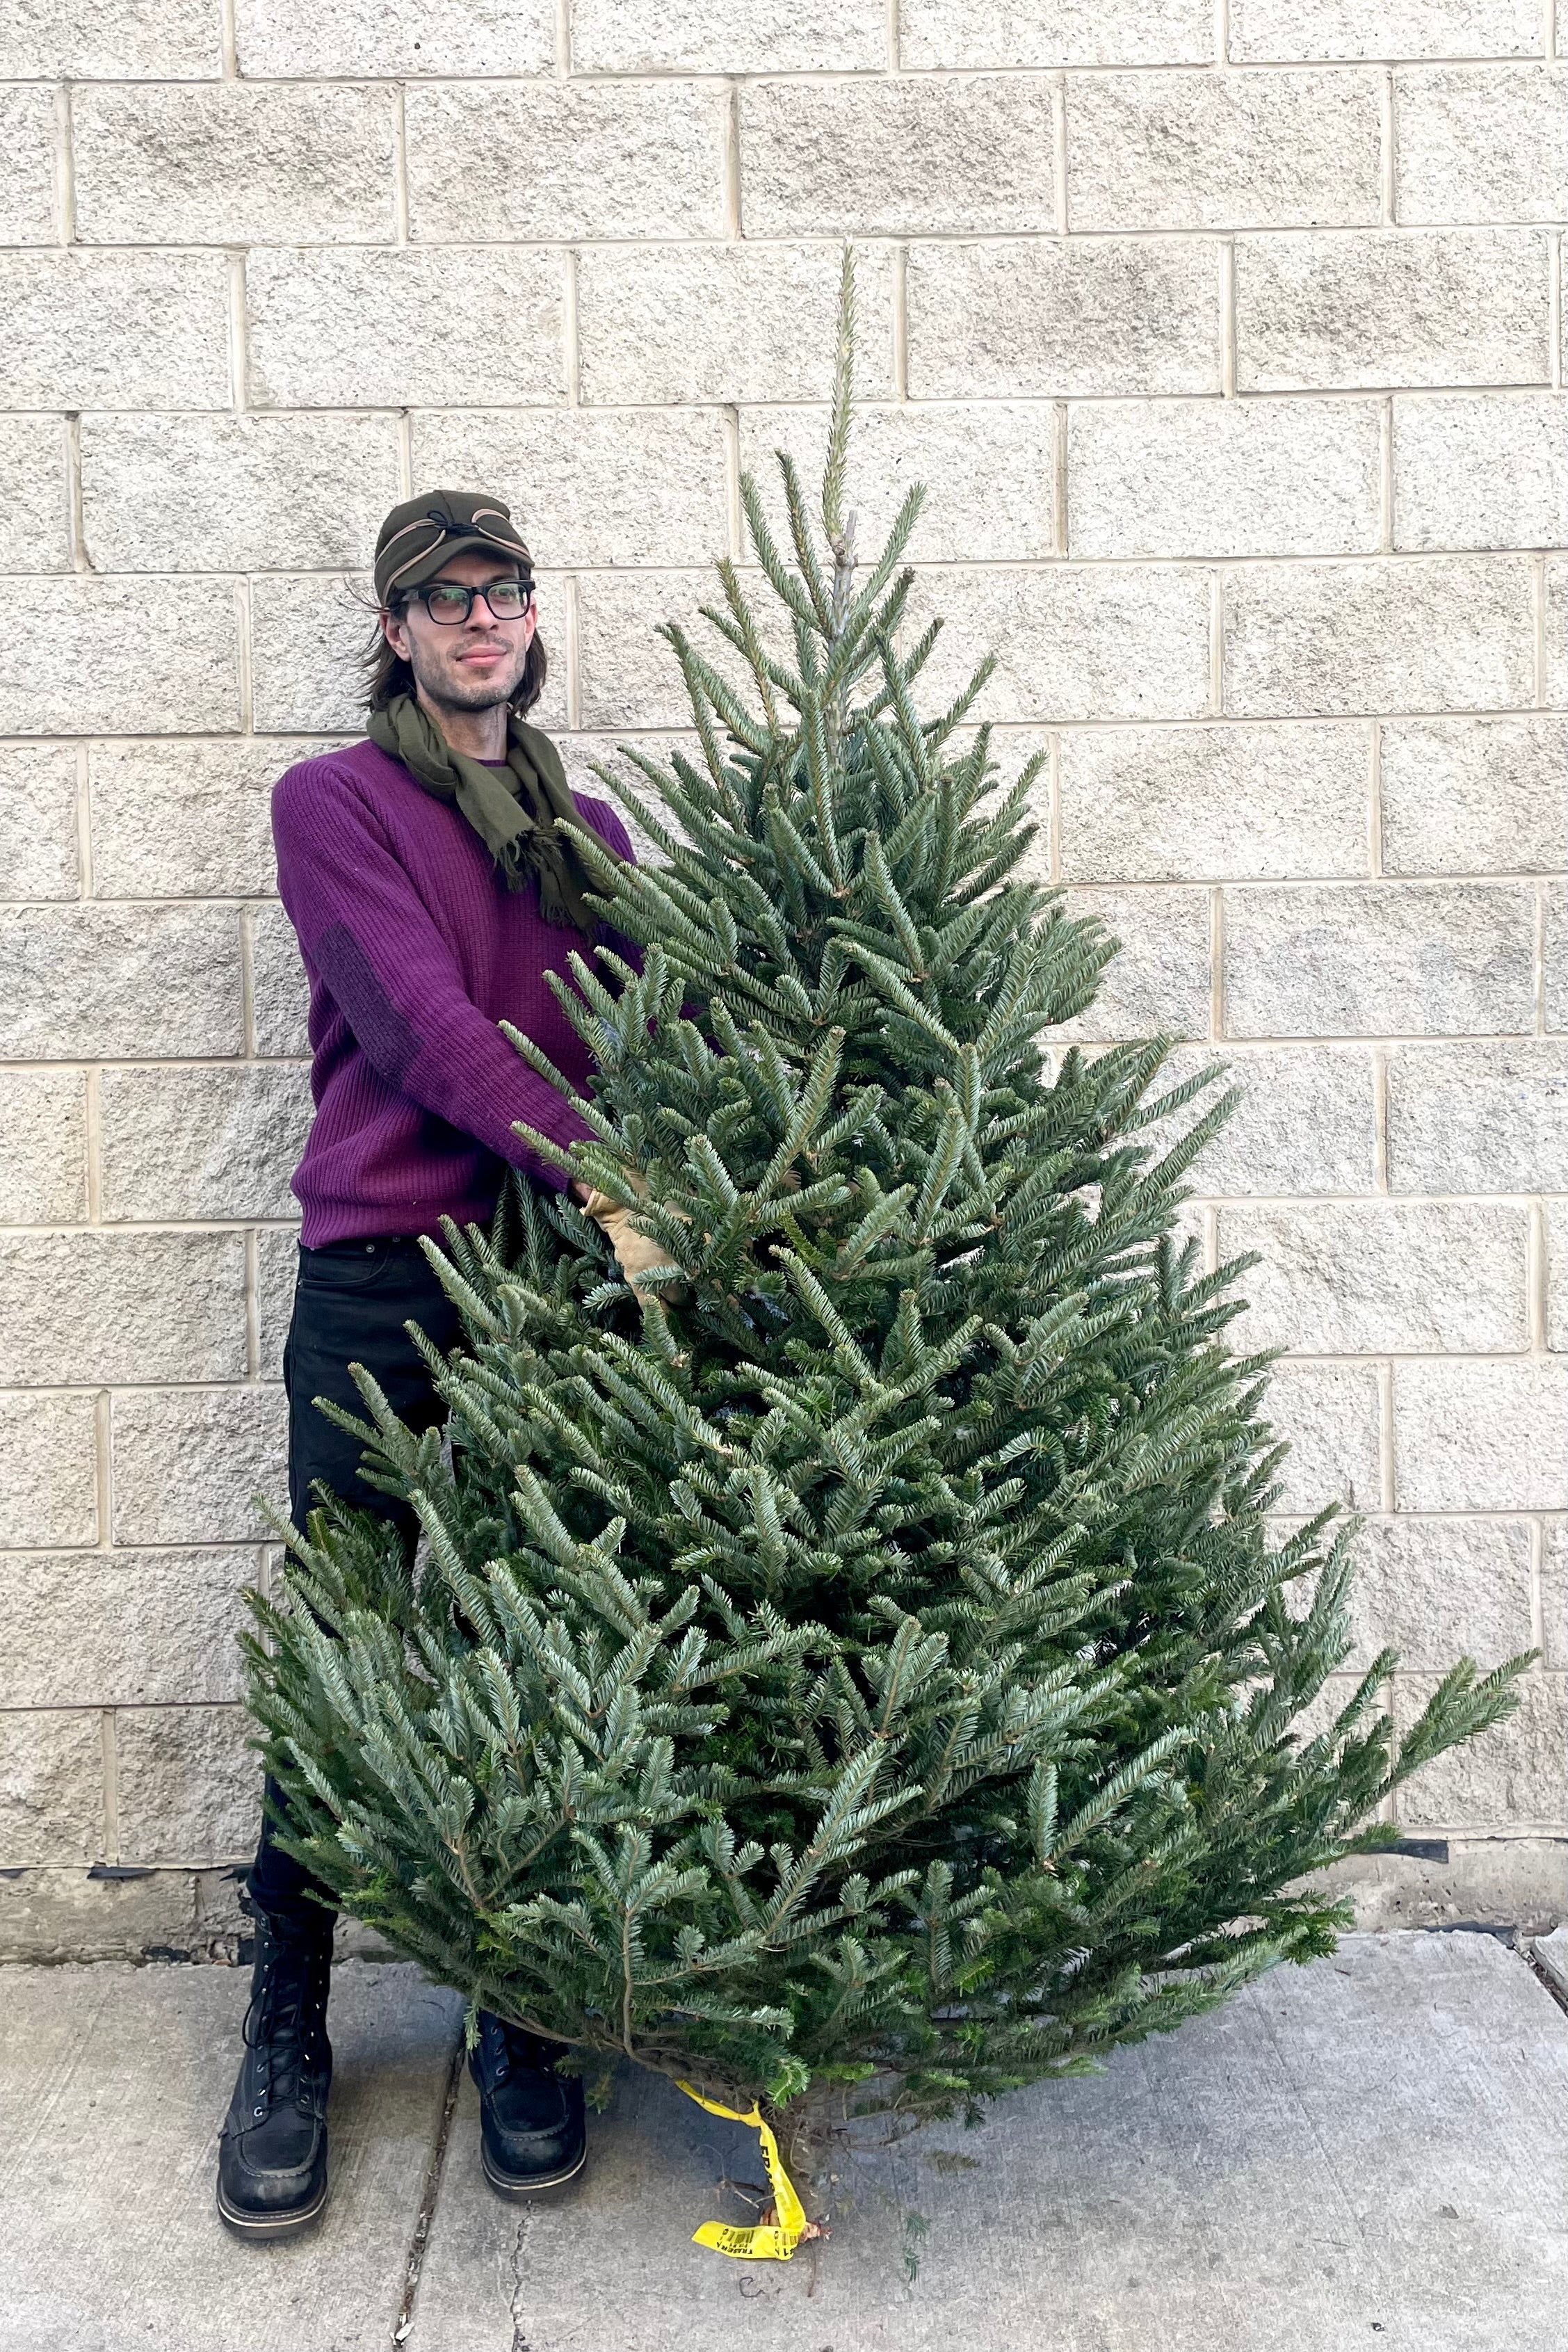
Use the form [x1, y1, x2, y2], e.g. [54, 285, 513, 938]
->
[366, 694, 613, 938]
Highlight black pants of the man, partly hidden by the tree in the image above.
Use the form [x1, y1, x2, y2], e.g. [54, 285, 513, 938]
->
[249, 1239, 461, 1933]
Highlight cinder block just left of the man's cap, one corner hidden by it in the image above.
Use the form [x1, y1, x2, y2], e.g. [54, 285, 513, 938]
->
[82, 417, 397, 572]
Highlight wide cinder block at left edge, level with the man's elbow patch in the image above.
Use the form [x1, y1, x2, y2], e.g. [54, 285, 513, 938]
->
[0, 905, 245, 1061]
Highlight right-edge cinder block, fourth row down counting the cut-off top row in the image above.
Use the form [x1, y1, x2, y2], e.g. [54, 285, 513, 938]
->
[1394, 393, 1568, 548]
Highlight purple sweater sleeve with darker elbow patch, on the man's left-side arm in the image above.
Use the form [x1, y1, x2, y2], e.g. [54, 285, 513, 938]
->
[273, 762, 630, 1190]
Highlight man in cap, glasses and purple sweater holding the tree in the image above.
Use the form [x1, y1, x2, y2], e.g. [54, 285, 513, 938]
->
[218, 492, 663, 2239]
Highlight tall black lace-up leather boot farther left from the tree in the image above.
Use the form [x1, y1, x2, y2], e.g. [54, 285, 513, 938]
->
[218, 1908, 332, 2239]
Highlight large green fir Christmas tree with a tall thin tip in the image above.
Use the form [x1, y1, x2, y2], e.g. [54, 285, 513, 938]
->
[247, 257, 1523, 2164]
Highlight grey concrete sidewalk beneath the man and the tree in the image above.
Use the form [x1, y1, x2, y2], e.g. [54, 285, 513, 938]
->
[0, 1933, 1568, 2352]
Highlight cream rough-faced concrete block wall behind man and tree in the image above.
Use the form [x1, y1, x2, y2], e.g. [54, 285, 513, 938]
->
[0, 0, 1568, 1950]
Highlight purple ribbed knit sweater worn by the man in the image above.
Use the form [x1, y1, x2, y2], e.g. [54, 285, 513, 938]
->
[273, 743, 637, 1249]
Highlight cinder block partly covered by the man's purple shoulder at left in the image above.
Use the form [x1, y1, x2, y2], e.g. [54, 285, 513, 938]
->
[87, 736, 315, 899]
